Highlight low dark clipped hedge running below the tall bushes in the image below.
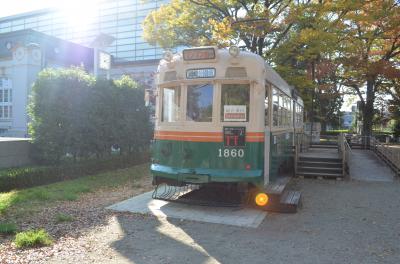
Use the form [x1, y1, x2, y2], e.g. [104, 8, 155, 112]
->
[0, 153, 149, 192]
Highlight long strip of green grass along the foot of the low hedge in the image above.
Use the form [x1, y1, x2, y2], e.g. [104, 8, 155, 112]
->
[0, 164, 150, 216]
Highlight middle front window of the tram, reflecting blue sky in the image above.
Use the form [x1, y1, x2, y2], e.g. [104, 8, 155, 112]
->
[186, 84, 213, 122]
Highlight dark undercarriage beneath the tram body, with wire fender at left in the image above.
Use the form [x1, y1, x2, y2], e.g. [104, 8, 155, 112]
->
[152, 177, 301, 213]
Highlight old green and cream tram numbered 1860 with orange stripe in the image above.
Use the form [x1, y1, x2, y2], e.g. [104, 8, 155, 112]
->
[151, 47, 303, 206]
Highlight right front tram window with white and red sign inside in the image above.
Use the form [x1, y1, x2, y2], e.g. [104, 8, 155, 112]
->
[221, 84, 250, 122]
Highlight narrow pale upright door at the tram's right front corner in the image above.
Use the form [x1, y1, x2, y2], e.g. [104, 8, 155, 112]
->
[264, 82, 271, 186]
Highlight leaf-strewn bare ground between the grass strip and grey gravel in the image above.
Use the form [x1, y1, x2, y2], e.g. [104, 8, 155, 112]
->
[0, 177, 153, 264]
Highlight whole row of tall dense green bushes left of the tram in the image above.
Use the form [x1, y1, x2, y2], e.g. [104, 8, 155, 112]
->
[29, 68, 152, 163]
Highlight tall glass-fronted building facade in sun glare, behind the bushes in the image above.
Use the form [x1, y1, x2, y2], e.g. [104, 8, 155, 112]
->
[0, 0, 169, 63]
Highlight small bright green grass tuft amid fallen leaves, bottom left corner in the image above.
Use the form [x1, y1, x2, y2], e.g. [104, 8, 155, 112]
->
[14, 229, 53, 248]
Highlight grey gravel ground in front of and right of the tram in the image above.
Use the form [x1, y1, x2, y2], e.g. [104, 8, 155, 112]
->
[0, 175, 400, 264]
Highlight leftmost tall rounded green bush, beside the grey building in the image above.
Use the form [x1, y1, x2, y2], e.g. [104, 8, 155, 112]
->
[29, 68, 94, 163]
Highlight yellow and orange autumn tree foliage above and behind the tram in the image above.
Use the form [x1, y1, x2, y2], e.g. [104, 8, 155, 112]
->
[144, 0, 400, 135]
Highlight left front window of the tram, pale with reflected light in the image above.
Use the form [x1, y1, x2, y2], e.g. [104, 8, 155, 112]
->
[162, 87, 181, 122]
